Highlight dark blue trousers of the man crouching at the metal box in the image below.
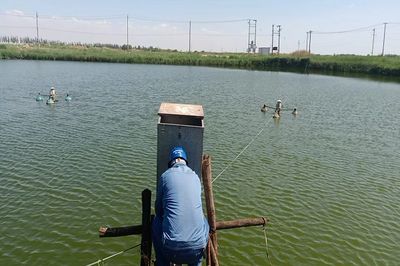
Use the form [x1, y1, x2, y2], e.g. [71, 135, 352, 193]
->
[151, 216, 204, 266]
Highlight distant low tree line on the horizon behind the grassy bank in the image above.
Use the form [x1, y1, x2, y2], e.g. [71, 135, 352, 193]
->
[0, 36, 177, 52]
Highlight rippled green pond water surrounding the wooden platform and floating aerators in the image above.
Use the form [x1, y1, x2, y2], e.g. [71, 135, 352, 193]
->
[0, 61, 400, 265]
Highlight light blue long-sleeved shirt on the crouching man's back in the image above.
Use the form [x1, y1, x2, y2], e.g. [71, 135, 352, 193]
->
[156, 163, 209, 249]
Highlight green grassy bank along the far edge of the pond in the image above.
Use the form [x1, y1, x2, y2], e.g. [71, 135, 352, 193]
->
[0, 44, 400, 76]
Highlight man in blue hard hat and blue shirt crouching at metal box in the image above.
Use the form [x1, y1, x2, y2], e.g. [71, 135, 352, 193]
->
[152, 147, 210, 266]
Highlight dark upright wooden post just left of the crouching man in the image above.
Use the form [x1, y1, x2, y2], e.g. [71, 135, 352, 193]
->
[140, 189, 152, 266]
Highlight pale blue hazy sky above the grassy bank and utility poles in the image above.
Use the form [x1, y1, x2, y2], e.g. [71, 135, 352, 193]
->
[0, 0, 400, 54]
